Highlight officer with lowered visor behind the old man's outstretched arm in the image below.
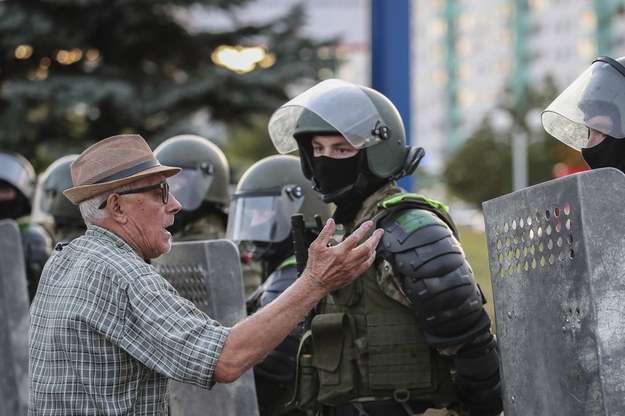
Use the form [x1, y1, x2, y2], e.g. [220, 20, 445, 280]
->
[227, 155, 331, 416]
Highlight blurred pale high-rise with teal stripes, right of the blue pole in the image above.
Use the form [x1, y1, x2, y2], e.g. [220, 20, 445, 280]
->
[411, 0, 625, 175]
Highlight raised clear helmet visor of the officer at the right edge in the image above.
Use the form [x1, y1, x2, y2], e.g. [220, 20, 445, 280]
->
[542, 58, 625, 150]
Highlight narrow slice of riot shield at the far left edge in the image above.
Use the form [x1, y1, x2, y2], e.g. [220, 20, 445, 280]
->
[0, 219, 29, 416]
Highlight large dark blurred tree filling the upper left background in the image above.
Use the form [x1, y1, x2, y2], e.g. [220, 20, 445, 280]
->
[0, 0, 337, 170]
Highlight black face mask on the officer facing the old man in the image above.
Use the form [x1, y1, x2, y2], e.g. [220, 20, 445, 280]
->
[312, 153, 361, 202]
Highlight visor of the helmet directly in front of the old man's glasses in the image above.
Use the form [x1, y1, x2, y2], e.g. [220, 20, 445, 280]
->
[167, 163, 215, 211]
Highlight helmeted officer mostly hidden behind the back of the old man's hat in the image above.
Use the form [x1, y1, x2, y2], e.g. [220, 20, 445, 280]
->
[32, 155, 87, 245]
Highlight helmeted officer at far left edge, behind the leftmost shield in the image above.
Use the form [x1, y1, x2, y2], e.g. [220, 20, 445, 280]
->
[0, 151, 52, 300]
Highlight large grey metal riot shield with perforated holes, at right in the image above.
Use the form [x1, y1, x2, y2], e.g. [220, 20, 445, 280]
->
[483, 168, 625, 416]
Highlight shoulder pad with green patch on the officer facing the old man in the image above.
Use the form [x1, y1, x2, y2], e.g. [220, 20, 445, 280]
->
[379, 208, 453, 253]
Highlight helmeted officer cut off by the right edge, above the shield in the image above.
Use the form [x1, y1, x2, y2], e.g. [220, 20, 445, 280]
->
[542, 56, 625, 172]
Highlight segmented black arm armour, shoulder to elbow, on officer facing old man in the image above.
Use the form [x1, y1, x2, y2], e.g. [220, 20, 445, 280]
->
[380, 209, 491, 348]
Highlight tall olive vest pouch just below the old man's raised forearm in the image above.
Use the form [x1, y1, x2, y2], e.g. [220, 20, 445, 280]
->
[311, 313, 357, 406]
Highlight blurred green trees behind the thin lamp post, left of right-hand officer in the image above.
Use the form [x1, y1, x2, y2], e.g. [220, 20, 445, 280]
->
[443, 78, 583, 206]
